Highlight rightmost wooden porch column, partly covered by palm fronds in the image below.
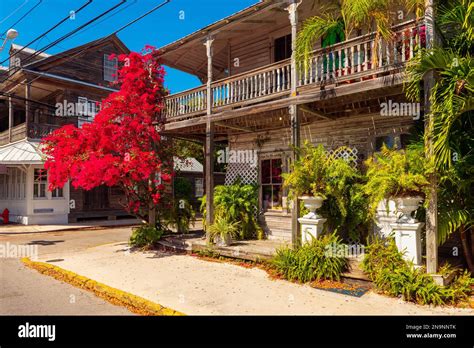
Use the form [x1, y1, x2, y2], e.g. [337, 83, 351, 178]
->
[423, 0, 438, 274]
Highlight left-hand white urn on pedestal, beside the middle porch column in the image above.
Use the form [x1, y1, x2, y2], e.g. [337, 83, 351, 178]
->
[298, 196, 326, 244]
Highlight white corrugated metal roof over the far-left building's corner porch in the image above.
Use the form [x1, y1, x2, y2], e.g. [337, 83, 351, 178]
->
[0, 140, 43, 165]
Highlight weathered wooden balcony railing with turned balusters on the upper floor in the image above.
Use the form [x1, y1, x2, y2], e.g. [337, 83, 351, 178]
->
[165, 20, 425, 122]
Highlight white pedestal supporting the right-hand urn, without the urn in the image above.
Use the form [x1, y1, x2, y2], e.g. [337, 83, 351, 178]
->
[390, 222, 424, 266]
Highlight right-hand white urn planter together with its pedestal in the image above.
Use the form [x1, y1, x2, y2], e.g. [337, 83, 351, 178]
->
[390, 197, 424, 266]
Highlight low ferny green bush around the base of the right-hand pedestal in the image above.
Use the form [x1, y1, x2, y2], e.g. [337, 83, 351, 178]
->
[362, 240, 474, 305]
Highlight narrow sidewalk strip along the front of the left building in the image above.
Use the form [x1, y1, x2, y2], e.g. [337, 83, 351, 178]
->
[0, 219, 141, 235]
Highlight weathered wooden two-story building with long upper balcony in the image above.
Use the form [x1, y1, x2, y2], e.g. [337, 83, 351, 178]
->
[157, 0, 425, 241]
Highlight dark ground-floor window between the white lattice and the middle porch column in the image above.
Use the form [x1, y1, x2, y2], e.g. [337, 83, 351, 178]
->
[260, 158, 282, 211]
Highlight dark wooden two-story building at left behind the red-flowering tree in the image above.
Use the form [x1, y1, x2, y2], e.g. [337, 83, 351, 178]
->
[0, 35, 129, 224]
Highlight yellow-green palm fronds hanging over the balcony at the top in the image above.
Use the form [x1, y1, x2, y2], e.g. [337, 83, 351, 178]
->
[296, 0, 424, 68]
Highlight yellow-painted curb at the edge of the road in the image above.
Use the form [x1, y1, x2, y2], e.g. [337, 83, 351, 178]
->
[21, 257, 185, 316]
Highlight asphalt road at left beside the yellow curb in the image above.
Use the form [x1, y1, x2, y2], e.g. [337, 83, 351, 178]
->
[0, 227, 137, 315]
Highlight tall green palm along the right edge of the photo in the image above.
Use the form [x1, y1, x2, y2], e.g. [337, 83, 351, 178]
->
[405, 0, 474, 273]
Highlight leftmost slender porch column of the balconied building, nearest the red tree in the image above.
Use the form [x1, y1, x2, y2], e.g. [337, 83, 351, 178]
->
[204, 36, 214, 239]
